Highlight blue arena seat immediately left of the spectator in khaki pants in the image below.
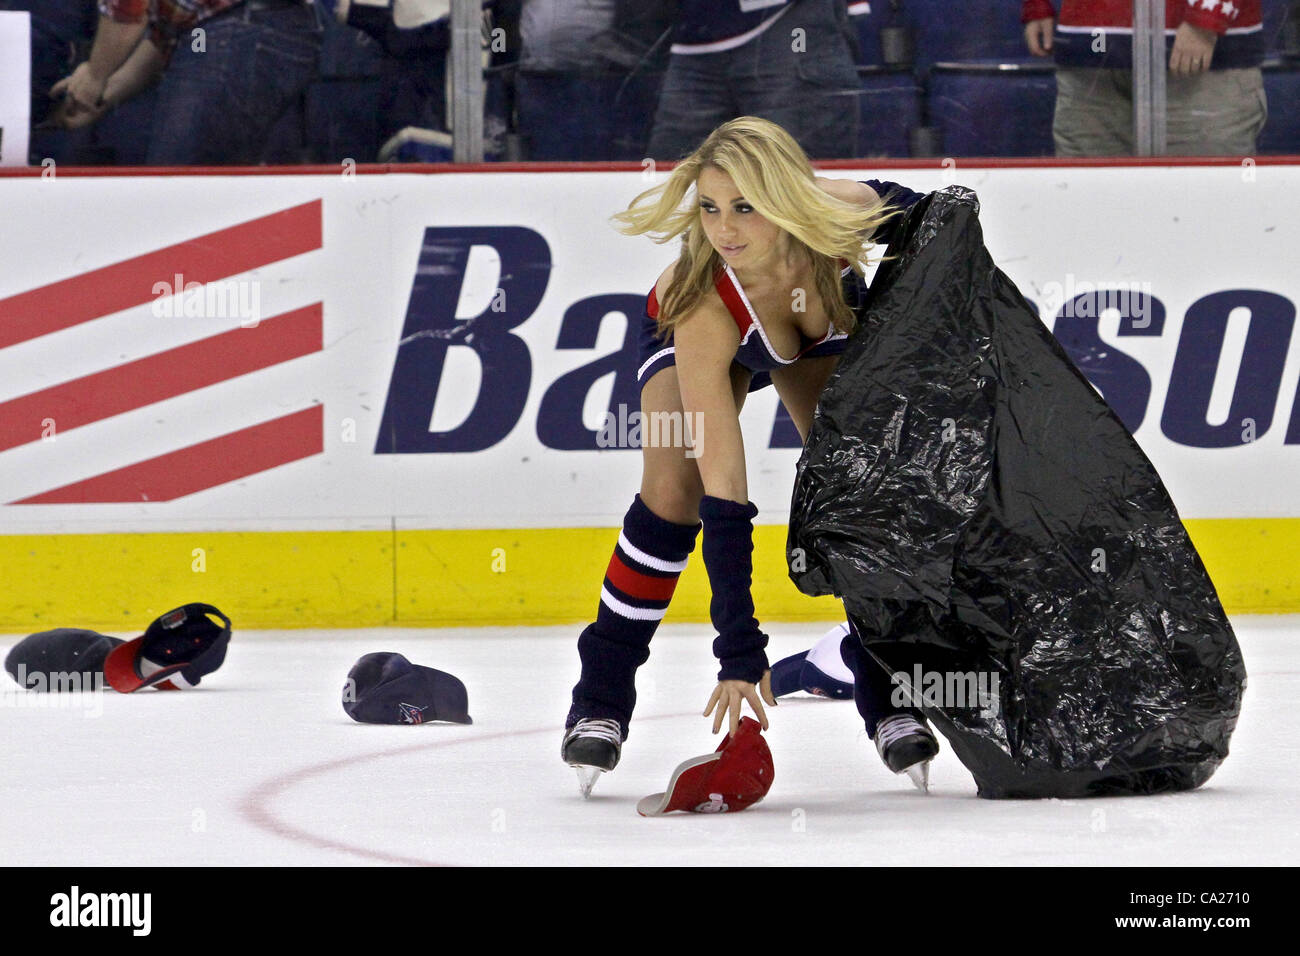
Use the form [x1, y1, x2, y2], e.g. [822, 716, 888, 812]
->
[927, 60, 1056, 156]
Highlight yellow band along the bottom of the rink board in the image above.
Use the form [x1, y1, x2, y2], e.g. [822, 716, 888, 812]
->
[0, 519, 1300, 632]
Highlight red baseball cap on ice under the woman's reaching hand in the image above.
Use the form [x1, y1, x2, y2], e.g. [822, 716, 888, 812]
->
[637, 717, 775, 817]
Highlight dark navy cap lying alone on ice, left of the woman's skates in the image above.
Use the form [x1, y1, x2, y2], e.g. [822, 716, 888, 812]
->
[343, 652, 473, 723]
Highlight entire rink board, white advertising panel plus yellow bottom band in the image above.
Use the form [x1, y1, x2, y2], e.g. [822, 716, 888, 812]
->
[0, 161, 1300, 631]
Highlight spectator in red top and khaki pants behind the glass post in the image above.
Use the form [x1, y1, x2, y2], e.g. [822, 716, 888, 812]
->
[1021, 0, 1268, 156]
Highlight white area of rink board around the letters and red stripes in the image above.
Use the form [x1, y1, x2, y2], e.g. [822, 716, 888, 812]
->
[0, 166, 1300, 533]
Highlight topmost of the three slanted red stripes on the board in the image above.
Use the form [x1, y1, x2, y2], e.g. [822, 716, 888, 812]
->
[0, 199, 321, 349]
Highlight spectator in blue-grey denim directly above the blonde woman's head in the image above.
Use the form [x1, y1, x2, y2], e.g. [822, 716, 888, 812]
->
[649, 0, 859, 160]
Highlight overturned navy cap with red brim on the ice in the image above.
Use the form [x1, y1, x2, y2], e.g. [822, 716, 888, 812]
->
[104, 604, 230, 693]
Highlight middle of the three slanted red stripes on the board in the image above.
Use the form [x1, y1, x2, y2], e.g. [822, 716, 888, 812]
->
[0, 302, 322, 451]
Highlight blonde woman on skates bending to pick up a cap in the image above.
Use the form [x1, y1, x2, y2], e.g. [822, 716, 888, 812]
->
[562, 116, 939, 795]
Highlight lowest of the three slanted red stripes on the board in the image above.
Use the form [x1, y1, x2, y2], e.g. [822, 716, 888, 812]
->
[9, 405, 325, 505]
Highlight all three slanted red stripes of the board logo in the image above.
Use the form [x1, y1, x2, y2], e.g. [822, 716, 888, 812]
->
[0, 199, 324, 505]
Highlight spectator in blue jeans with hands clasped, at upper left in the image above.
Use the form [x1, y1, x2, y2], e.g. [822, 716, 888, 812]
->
[52, 0, 321, 165]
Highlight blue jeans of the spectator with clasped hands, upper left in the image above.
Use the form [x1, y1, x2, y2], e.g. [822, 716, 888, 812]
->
[148, 7, 321, 165]
